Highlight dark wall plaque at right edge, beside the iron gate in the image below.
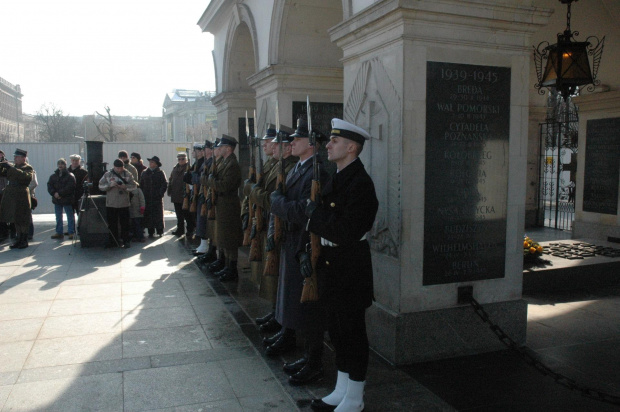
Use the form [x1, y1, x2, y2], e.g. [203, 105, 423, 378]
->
[583, 117, 620, 215]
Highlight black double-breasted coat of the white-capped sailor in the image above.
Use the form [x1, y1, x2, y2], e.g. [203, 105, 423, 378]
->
[308, 159, 379, 311]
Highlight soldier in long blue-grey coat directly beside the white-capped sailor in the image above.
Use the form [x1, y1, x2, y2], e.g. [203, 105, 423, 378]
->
[265, 120, 327, 385]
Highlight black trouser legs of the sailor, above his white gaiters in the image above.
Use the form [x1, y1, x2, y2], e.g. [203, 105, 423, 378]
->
[327, 309, 369, 382]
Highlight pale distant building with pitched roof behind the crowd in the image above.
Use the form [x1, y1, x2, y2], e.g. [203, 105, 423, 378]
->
[162, 89, 218, 142]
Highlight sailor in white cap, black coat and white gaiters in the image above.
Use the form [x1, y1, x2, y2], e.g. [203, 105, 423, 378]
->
[302, 119, 379, 411]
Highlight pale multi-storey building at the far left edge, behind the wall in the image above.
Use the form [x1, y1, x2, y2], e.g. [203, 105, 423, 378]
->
[0, 77, 24, 142]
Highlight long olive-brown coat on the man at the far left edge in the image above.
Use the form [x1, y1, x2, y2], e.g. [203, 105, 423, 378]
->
[0, 163, 34, 225]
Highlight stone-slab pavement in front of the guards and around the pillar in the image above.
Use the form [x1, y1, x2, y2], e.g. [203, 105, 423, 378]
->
[0, 215, 620, 412]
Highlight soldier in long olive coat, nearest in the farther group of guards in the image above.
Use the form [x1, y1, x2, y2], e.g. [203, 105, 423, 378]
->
[207, 135, 243, 282]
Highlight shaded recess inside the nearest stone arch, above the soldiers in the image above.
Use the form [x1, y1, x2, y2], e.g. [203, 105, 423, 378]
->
[268, 0, 343, 67]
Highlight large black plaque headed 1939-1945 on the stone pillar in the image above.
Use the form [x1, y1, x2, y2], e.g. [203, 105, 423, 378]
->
[423, 62, 510, 285]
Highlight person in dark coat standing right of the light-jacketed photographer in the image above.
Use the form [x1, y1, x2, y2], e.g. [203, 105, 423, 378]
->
[140, 156, 168, 238]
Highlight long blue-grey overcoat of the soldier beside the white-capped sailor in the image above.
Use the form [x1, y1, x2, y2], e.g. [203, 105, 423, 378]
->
[271, 158, 327, 331]
